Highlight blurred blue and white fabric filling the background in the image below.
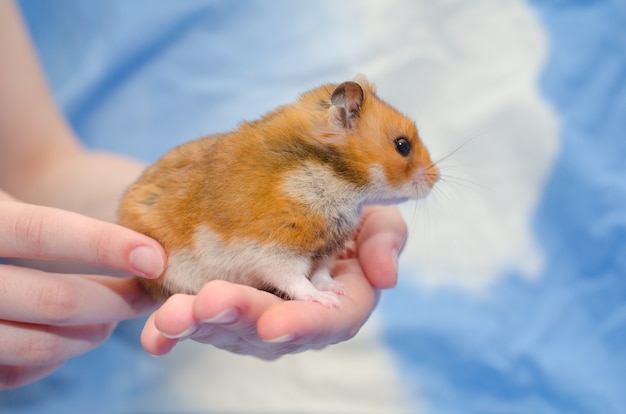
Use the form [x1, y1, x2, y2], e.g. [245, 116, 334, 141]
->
[0, 0, 626, 414]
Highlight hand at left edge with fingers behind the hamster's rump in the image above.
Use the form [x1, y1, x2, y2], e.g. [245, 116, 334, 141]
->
[0, 191, 166, 389]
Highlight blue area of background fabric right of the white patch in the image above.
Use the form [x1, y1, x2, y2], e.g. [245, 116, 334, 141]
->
[382, 1, 626, 414]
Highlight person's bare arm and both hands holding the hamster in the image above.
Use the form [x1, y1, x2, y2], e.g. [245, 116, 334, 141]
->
[0, 1, 406, 389]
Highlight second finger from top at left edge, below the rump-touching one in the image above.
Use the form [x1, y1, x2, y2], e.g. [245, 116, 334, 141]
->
[0, 265, 155, 326]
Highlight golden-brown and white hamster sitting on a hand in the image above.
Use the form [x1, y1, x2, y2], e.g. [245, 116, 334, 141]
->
[118, 75, 439, 308]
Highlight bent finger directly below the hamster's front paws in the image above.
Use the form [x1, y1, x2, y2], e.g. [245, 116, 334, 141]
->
[257, 259, 378, 346]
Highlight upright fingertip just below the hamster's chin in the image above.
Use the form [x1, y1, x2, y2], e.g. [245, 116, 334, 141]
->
[358, 206, 407, 289]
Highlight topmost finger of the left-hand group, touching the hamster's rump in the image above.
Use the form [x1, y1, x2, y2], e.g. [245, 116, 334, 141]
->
[0, 201, 166, 278]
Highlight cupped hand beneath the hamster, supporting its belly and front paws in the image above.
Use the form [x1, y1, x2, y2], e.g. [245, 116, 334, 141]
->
[141, 206, 407, 359]
